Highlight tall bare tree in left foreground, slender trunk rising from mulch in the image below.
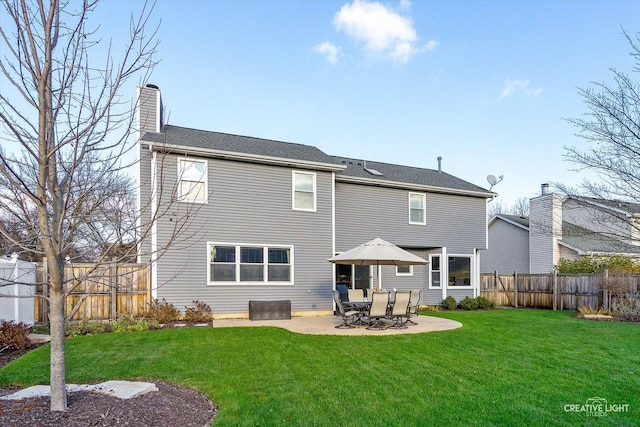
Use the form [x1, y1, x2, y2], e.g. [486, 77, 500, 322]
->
[0, 0, 157, 411]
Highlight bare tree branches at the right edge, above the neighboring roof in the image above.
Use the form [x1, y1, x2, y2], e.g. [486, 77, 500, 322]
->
[557, 30, 640, 239]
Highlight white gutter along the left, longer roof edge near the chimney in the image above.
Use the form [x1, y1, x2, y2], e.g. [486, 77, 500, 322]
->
[140, 140, 347, 172]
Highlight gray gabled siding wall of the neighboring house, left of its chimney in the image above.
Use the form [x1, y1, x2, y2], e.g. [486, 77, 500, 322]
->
[480, 218, 529, 274]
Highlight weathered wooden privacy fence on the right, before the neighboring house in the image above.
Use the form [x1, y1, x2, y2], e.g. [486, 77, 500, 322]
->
[480, 273, 640, 310]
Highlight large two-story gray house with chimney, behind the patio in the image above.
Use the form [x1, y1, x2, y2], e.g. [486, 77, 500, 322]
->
[138, 86, 494, 318]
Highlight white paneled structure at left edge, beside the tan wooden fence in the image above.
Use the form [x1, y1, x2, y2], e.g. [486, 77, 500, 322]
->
[0, 254, 36, 326]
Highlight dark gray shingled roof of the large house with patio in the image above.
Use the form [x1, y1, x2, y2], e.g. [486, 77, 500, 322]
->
[141, 125, 494, 198]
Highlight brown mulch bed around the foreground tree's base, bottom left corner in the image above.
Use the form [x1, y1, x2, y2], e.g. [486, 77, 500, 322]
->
[0, 349, 218, 427]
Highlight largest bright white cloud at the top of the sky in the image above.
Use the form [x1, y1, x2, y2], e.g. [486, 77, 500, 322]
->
[333, 0, 420, 63]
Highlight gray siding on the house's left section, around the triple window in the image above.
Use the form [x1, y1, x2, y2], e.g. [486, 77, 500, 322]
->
[152, 156, 333, 314]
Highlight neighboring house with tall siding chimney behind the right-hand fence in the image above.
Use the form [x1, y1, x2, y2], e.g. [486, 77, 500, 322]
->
[481, 186, 640, 274]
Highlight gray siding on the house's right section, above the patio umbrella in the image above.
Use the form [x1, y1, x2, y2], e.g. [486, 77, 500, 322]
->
[336, 182, 486, 254]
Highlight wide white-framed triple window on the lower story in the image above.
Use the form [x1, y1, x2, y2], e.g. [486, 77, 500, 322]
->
[208, 243, 293, 284]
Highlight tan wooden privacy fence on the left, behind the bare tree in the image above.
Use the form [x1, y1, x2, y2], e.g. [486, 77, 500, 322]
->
[34, 264, 151, 324]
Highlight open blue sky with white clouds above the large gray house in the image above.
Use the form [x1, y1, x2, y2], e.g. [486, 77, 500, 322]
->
[97, 0, 640, 205]
